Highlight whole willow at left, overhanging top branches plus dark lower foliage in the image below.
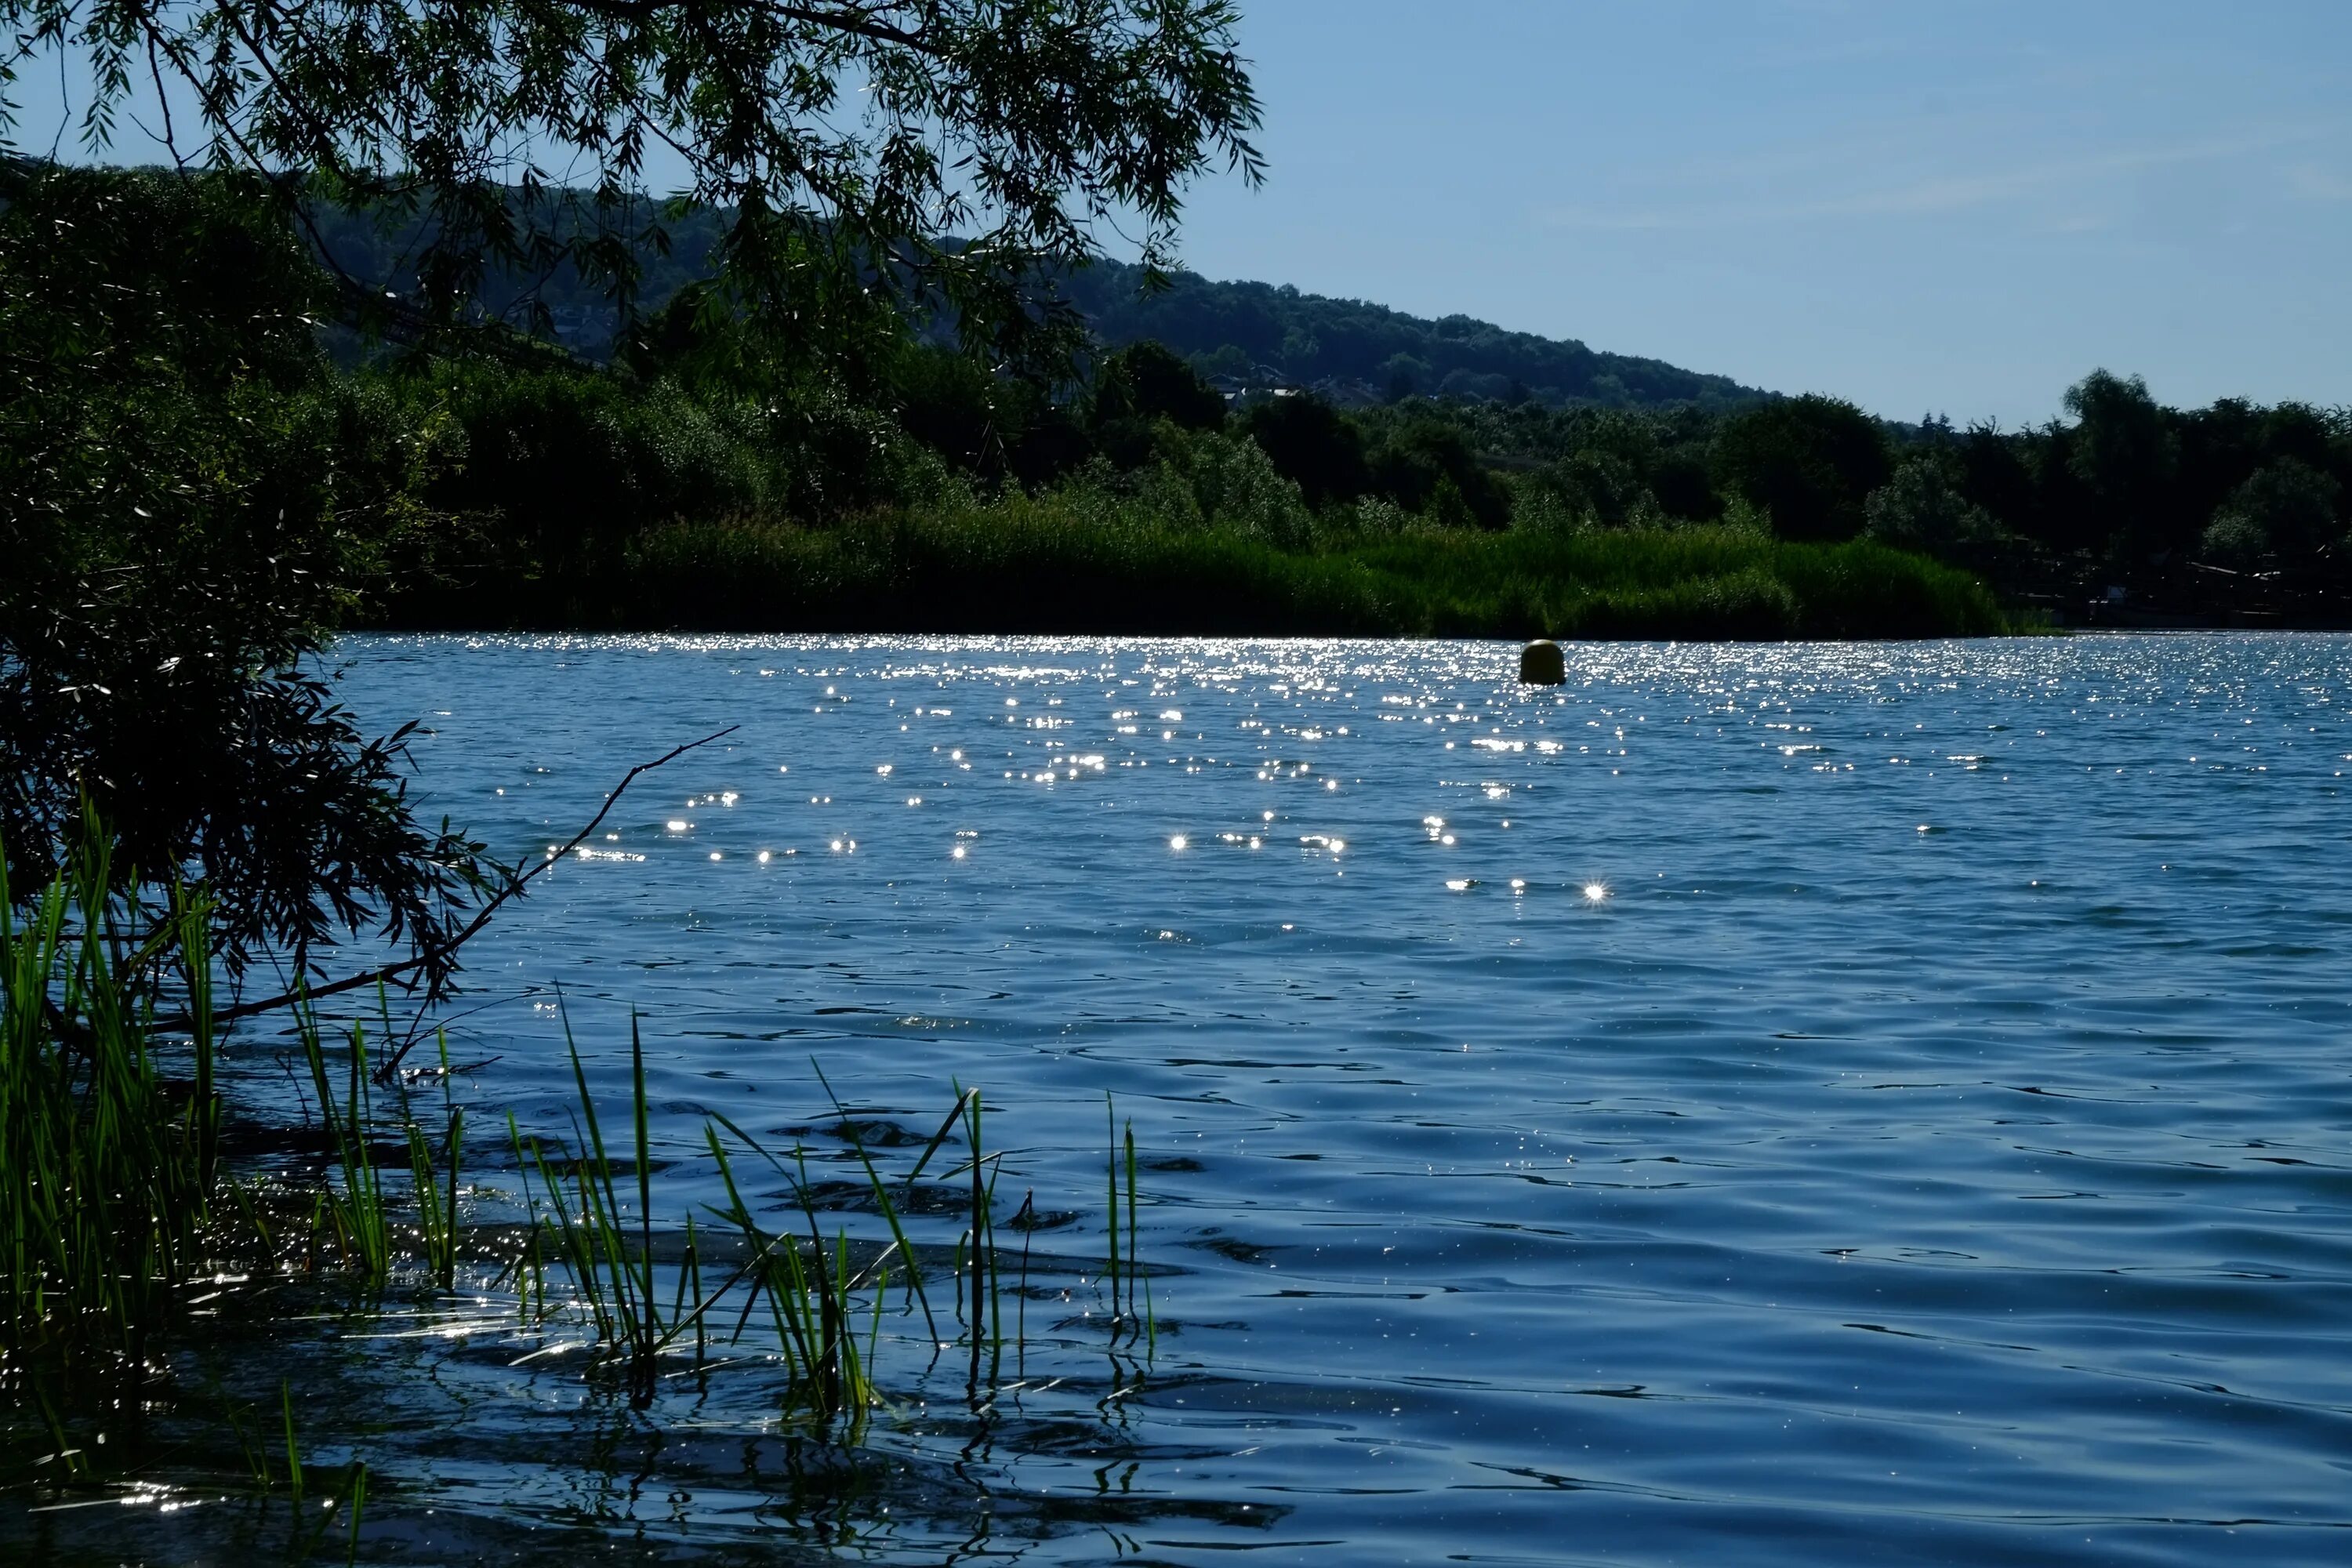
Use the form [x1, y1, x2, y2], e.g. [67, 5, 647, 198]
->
[0, 0, 1261, 1006]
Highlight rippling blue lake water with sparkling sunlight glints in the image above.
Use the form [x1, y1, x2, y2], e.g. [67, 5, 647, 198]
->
[111, 635, 2352, 1563]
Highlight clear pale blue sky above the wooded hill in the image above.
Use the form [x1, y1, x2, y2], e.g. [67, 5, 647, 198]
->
[16, 0, 2352, 423]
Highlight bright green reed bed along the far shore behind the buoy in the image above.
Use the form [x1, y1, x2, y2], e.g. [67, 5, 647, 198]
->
[374, 512, 2023, 642]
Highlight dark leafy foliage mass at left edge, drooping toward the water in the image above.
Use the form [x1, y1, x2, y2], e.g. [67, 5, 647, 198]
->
[0, 165, 489, 985]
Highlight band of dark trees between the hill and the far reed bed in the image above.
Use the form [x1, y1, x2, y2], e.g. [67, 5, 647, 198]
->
[381, 319, 2352, 630]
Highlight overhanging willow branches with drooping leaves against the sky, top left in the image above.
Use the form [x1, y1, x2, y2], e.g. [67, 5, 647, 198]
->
[0, 0, 1261, 361]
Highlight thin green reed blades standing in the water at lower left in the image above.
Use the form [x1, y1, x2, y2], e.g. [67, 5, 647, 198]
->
[0, 832, 1152, 1486]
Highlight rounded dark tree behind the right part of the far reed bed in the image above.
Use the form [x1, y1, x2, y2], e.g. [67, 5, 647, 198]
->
[1712, 395, 1891, 539]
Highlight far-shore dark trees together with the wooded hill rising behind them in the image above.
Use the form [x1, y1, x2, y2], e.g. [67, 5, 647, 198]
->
[151, 172, 2352, 626]
